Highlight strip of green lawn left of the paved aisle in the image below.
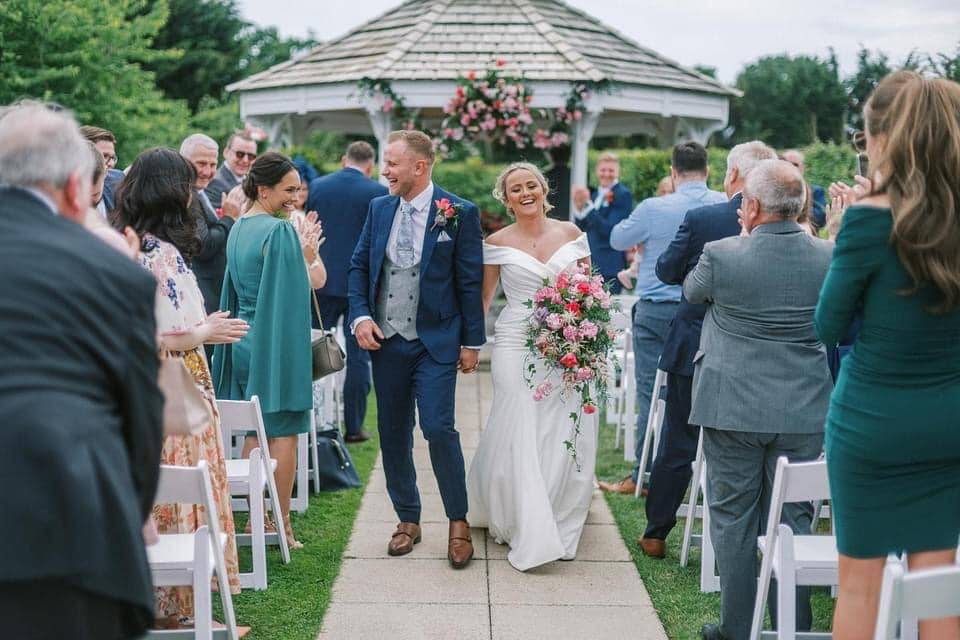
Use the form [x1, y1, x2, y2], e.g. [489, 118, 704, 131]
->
[233, 396, 379, 640]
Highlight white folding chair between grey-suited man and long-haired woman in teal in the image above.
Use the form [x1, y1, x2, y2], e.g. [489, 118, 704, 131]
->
[750, 456, 839, 640]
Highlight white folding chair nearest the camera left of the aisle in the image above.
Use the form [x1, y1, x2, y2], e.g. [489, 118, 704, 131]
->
[147, 460, 238, 640]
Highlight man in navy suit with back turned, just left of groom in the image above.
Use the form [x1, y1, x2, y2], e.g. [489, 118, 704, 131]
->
[307, 141, 387, 442]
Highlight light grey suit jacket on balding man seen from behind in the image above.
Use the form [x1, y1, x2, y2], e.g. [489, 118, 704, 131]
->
[683, 221, 833, 433]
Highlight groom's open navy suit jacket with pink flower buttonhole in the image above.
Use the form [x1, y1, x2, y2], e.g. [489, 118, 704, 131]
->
[348, 186, 486, 364]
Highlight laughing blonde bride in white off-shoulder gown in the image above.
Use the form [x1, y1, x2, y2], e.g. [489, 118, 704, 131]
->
[467, 162, 597, 571]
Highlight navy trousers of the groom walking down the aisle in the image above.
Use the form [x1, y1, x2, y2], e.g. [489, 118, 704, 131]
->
[370, 335, 467, 524]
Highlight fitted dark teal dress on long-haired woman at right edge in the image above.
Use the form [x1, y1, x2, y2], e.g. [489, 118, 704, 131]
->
[815, 206, 960, 558]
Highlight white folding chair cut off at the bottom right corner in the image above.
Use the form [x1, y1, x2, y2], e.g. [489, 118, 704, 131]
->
[873, 562, 960, 640]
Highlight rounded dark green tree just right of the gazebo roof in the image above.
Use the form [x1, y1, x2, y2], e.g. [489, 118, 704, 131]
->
[732, 54, 847, 148]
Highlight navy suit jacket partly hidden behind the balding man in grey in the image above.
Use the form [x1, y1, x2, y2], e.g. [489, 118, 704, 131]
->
[657, 194, 742, 376]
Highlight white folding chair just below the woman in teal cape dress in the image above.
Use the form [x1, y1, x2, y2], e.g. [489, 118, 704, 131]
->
[217, 396, 290, 591]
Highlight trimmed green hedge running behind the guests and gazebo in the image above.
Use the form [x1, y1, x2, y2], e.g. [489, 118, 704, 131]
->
[288, 143, 856, 231]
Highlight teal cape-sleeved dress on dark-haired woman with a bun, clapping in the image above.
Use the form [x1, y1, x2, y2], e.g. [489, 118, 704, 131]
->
[213, 215, 313, 438]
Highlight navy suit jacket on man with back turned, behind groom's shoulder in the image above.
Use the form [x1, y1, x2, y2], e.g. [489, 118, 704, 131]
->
[306, 169, 387, 298]
